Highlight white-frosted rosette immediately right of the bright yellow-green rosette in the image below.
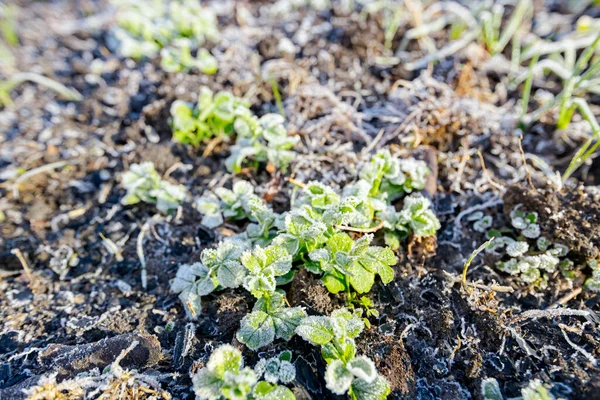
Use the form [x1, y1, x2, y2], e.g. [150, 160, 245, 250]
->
[225, 112, 300, 173]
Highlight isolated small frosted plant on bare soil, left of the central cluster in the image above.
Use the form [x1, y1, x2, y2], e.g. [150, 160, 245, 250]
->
[121, 162, 187, 214]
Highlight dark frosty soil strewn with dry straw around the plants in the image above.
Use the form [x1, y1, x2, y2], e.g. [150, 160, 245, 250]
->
[0, 0, 600, 400]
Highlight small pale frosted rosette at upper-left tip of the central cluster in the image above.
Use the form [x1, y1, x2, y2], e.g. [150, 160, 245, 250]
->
[196, 181, 255, 228]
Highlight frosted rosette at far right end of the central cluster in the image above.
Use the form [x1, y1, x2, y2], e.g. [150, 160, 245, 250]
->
[377, 194, 441, 249]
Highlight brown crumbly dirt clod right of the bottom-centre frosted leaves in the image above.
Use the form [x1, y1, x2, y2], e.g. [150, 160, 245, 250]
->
[357, 331, 416, 399]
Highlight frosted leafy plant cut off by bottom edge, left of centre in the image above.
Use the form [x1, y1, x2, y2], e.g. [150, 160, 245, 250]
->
[192, 344, 295, 400]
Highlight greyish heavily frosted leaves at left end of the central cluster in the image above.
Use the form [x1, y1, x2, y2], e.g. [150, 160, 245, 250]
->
[171, 240, 247, 319]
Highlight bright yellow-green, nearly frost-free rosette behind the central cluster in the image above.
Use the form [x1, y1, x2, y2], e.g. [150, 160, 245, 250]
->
[171, 87, 250, 146]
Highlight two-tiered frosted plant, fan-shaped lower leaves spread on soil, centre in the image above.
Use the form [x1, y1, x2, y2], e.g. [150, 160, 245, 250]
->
[236, 245, 306, 350]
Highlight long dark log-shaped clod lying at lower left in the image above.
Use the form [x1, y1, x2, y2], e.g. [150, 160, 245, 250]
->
[38, 333, 162, 377]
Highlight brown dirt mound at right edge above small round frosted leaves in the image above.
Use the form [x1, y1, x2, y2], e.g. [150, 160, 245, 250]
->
[504, 185, 600, 262]
